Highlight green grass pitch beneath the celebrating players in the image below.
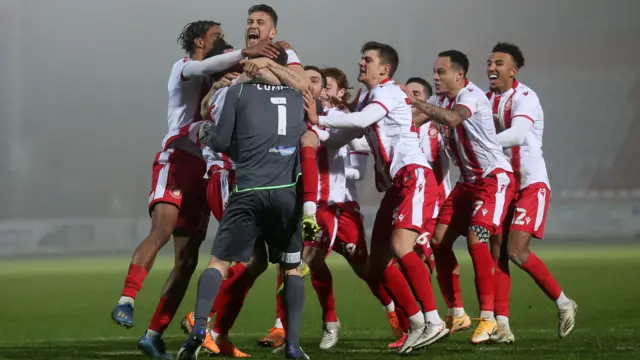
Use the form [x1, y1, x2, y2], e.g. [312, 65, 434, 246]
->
[0, 245, 640, 360]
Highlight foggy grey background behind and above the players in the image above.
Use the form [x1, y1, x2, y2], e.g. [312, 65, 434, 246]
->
[0, 0, 640, 255]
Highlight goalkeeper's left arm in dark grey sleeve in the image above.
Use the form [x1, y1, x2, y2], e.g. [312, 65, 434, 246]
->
[199, 85, 242, 153]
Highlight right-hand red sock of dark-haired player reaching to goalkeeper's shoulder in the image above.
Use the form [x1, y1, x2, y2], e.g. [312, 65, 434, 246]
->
[399, 251, 438, 312]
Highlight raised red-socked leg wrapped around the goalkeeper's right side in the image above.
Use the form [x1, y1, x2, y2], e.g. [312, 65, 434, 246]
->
[300, 130, 320, 241]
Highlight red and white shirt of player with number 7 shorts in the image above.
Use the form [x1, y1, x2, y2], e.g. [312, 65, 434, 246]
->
[429, 80, 512, 183]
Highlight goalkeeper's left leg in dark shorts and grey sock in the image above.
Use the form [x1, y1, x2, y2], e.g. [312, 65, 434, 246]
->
[178, 192, 262, 360]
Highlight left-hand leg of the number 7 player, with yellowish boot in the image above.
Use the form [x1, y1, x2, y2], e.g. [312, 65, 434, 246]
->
[431, 184, 471, 334]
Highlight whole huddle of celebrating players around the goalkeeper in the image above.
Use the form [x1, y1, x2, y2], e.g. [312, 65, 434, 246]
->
[111, 5, 577, 359]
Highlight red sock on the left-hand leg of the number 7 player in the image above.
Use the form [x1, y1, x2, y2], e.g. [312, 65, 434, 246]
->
[432, 244, 464, 309]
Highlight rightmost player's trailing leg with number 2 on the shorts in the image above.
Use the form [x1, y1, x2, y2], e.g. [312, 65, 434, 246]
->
[507, 183, 578, 338]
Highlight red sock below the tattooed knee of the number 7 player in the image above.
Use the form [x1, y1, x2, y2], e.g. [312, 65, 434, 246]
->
[469, 243, 496, 311]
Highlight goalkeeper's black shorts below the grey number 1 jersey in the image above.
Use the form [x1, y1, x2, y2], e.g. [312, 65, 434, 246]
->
[211, 186, 303, 268]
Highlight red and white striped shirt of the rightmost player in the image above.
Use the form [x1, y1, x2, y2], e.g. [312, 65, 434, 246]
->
[486, 80, 550, 190]
